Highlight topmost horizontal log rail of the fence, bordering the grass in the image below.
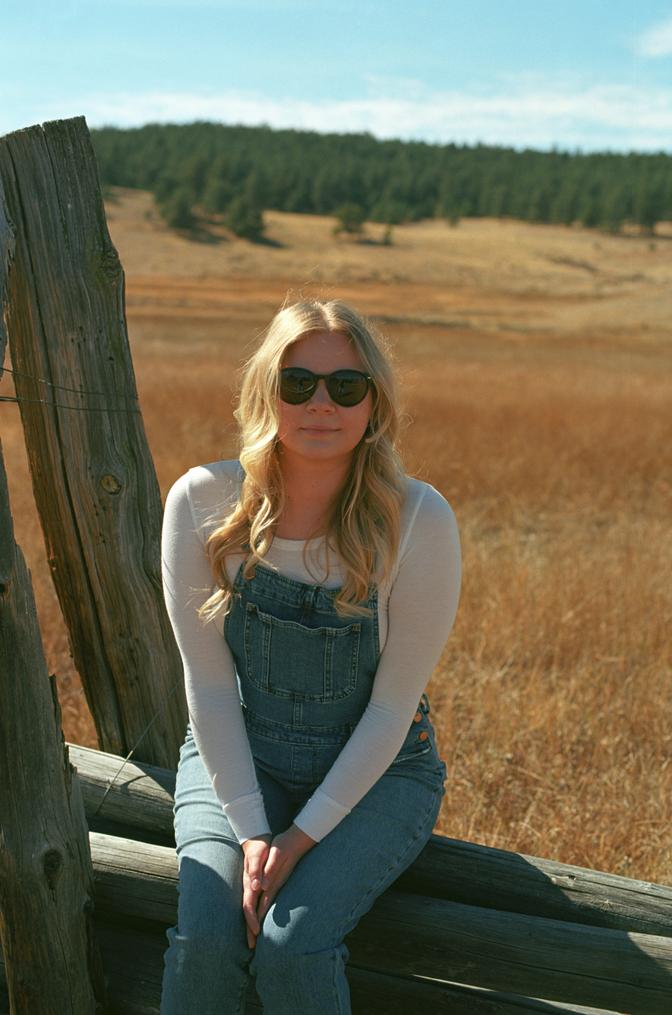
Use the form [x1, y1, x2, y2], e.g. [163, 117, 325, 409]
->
[68, 744, 672, 943]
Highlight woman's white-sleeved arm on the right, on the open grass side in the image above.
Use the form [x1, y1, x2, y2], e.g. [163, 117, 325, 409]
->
[294, 487, 461, 841]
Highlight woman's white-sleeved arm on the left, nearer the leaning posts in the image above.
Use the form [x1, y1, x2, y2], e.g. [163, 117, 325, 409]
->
[161, 473, 270, 842]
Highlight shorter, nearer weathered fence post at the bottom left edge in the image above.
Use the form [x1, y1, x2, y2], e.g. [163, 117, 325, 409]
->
[0, 187, 104, 1015]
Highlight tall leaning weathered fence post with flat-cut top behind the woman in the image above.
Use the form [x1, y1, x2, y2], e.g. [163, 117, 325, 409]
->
[0, 117, 187, 768]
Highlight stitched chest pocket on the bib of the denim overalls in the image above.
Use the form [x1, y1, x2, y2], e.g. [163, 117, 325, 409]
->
[244, 603, 361, 702]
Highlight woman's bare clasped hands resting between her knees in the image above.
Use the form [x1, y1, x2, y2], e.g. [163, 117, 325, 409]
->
[243, 823, 317, 948]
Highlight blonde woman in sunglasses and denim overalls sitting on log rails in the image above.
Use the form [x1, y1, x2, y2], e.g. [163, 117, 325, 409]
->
[161, 299, 460, 1015]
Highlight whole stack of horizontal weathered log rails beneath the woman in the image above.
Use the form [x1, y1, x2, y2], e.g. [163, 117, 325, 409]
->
[2, 745, 672, 1015]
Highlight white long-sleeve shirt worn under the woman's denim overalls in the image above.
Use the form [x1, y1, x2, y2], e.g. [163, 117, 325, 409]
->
[161, 460, 461, 842]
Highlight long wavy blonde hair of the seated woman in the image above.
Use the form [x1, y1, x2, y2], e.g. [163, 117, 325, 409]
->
[198, 299, 405, 620]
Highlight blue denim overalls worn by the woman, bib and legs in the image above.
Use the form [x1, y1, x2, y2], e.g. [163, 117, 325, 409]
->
[160, 565, 447, 1015]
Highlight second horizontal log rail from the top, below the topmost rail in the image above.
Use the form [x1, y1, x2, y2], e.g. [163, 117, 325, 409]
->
[90, 832, 672, 1015]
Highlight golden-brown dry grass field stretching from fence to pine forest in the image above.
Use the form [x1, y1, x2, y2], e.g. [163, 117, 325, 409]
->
[1, 191, 672, 883]
